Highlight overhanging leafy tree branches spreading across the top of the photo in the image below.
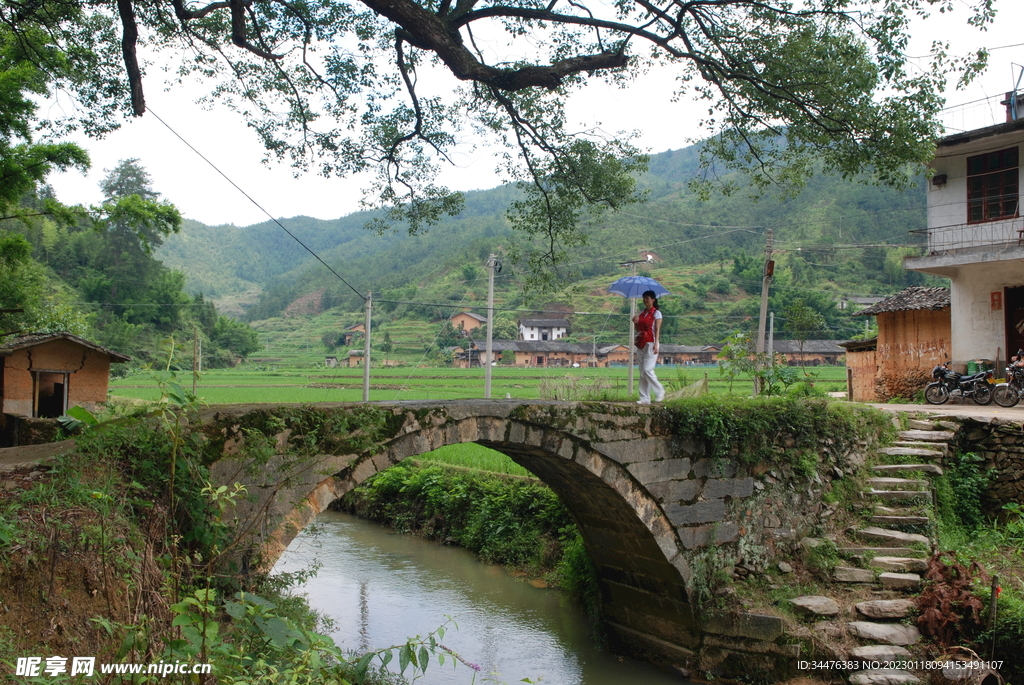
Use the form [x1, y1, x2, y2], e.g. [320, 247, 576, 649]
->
[0, 0, 994, 282]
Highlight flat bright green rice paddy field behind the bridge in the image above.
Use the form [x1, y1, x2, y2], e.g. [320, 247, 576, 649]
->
[111, 365, 846, 404]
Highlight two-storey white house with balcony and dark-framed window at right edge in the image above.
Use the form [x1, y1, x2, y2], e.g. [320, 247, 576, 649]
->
[903, 93, 1024, 366]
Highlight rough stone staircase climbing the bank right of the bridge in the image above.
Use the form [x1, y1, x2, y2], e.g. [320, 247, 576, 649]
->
[794, 420, 956, 685]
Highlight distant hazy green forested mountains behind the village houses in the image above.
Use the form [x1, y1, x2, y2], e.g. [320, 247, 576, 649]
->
[158, 142, 937, 344]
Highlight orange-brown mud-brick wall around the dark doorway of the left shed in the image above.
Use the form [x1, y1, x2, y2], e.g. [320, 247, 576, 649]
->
[0, 340, 111, 417]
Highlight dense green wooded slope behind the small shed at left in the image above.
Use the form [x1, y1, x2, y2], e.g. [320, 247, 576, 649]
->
[0, 160, 259, 372]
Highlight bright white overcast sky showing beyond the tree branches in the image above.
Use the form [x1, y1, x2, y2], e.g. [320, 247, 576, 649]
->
[48, 0, 1024, 226]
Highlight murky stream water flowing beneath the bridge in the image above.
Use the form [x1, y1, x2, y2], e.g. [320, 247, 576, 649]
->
[274, 512, 680, 685]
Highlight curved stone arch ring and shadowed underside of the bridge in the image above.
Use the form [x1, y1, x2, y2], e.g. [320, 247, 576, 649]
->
[264, 417, 696, 655]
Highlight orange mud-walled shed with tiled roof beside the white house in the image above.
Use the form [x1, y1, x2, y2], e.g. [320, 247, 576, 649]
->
[848, 286, 952, 401]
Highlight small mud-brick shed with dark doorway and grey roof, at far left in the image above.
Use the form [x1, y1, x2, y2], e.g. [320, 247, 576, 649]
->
[0, 333, 131, 419]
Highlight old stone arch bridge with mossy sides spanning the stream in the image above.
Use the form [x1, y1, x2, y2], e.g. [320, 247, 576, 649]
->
[203, 400, 863, 676]
